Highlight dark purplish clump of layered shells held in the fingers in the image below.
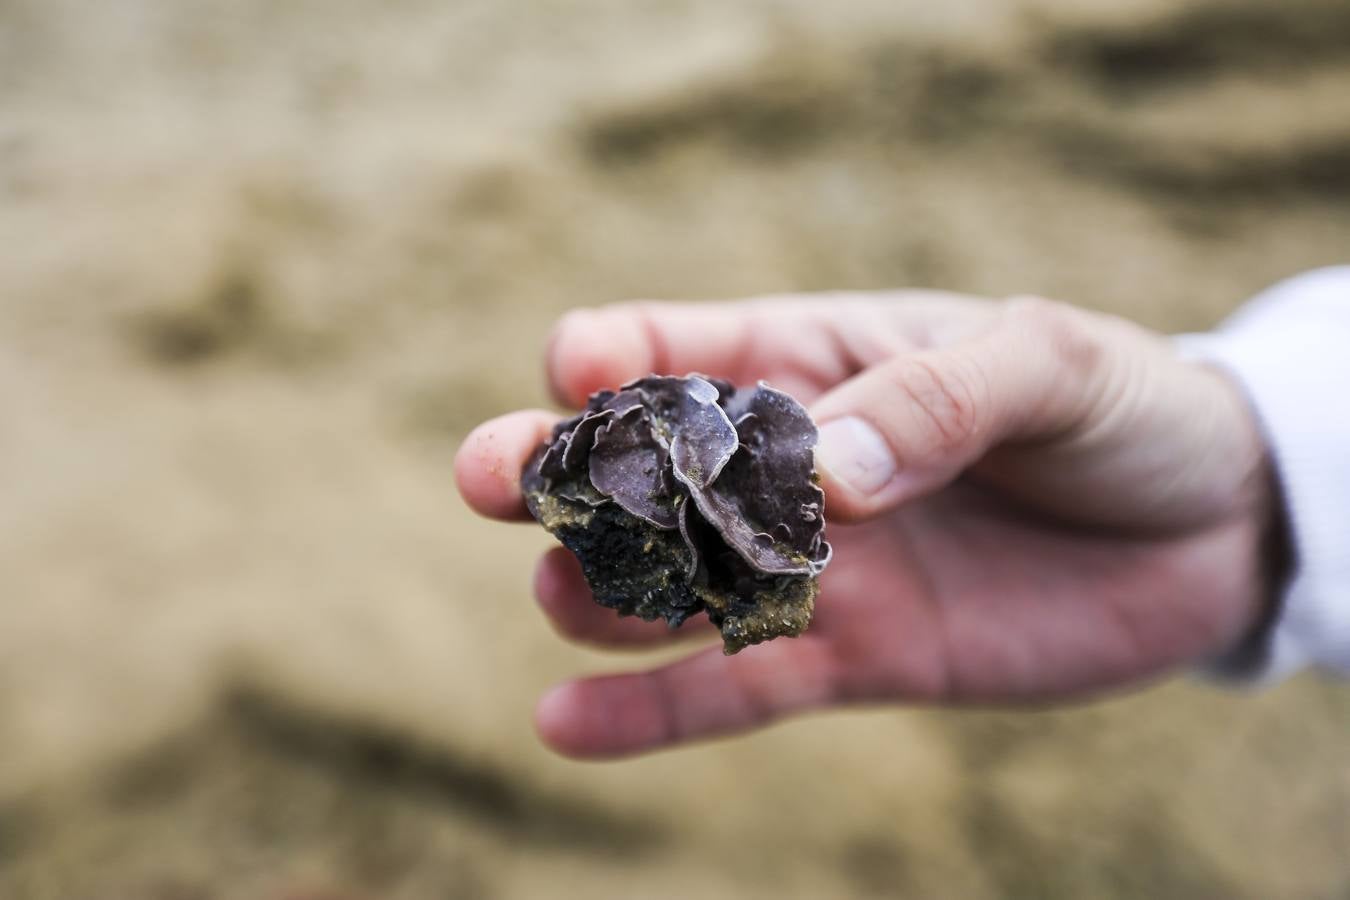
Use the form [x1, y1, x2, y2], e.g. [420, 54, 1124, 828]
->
[521, 376, 829, 653]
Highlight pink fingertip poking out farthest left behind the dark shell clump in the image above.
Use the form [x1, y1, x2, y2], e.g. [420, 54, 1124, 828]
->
[455, 409, 558, 522]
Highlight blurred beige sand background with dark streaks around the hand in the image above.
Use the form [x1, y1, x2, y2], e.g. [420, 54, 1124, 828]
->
[0, 0, 1350, 900]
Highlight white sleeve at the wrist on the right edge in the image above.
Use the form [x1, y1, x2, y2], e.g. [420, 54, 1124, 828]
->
[1177, 266, 1350, 681]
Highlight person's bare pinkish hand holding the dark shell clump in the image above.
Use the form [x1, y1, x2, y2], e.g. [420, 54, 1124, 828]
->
[455, 291, 1277, 758]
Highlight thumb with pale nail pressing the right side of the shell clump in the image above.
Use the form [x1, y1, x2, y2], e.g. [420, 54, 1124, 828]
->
[811, 298, 1106, 521]
